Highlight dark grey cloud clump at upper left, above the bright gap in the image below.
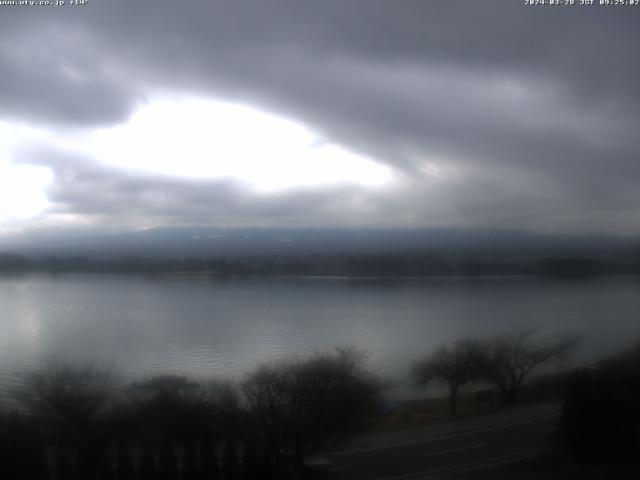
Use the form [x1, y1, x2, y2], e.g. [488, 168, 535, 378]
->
[0, 16, 136, 125]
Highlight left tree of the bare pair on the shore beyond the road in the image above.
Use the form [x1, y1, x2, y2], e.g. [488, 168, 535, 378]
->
[411, 338, 487, 415]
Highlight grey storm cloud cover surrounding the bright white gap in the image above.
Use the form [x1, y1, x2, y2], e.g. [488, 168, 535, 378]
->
[0, 0, 640, 231]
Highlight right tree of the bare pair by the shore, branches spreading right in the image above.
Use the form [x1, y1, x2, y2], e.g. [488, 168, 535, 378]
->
[486, 328, 579, 405]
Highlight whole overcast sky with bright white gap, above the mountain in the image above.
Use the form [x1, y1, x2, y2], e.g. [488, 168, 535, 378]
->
[0, 0, 640, 241]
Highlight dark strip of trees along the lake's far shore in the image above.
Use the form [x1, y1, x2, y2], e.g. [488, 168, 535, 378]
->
[0, 252, 640, 278]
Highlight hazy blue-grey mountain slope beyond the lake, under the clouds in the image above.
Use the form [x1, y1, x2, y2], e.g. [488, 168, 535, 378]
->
[0, 227, 640, 258]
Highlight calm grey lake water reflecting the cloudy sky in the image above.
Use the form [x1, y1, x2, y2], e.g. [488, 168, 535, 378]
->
[0, 275, 640, 402]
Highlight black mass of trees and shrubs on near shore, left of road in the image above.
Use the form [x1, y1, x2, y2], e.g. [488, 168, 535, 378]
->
[8, 349, 378, 480]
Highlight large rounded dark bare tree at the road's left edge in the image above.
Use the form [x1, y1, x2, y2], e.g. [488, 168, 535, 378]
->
[242, 349, 378, 474]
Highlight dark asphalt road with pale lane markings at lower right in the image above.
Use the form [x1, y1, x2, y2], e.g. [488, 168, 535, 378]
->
[329, 414, 558, 480]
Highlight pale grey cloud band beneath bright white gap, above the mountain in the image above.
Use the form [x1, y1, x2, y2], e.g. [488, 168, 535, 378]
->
[25, 146, 638, 231]
